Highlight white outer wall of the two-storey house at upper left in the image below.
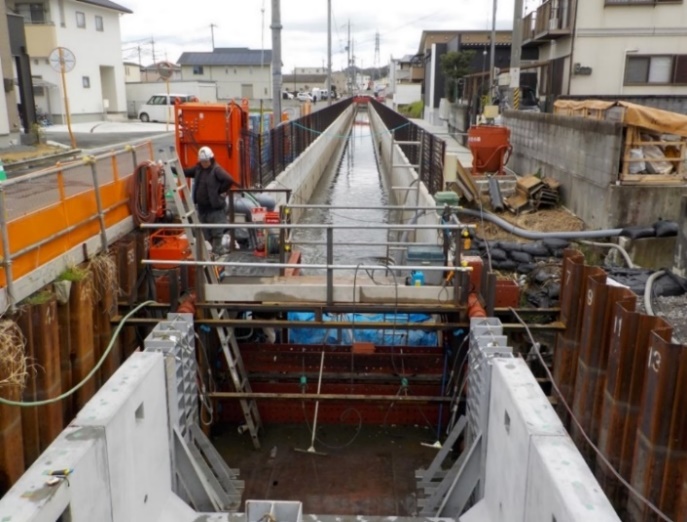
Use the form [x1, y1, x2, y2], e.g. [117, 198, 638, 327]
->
[31, 1, 126, 121]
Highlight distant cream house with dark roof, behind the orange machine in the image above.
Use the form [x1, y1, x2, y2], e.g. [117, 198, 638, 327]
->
[177, 47, 272, 100]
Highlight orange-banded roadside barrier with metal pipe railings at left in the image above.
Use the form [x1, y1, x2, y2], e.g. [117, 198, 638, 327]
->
[0, 141, 153, 310]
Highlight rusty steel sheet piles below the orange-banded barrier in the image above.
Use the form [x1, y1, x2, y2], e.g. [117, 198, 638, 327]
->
[0, 239, 148, 496]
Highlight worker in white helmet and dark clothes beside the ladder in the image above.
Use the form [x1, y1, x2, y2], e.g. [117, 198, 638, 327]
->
[184, 147, 240, 254]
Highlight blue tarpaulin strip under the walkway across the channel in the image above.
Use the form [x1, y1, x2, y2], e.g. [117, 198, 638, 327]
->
[287, 312, 439, 346]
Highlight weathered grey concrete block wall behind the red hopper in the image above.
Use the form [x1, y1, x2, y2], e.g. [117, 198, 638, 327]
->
[504, 112, 622, 228]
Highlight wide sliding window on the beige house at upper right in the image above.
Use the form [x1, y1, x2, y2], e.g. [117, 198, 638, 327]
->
[624, 54, 687, 85]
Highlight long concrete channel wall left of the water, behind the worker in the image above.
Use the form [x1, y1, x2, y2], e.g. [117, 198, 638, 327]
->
[267, 104, 355, 222]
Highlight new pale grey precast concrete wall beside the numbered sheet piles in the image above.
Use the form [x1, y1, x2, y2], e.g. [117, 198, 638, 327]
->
[459, 359, 620, 522]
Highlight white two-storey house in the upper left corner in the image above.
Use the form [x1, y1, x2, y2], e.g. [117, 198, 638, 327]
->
[6, 0, 131, 122]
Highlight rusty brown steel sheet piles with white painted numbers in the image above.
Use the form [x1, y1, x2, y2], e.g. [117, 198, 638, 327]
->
[554, 250, 687, 522]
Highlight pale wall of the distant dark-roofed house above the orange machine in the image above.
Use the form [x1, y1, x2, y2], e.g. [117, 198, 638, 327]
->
[181, 62, 272, 100]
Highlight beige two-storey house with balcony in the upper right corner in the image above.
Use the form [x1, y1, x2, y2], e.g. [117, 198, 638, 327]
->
[523, 0, 687, 105]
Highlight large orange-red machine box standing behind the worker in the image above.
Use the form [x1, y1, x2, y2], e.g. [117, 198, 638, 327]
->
[174, 101, 250, 187]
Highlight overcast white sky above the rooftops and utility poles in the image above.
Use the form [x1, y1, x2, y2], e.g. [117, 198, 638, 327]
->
[116, 0, 537, 74]
